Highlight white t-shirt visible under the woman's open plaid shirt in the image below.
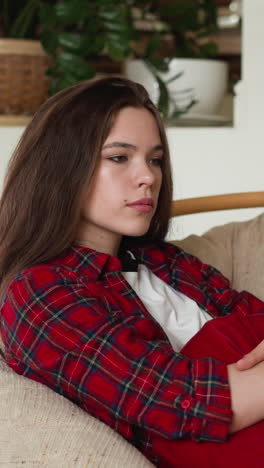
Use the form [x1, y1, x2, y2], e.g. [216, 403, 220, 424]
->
[123, 265, 212, 352]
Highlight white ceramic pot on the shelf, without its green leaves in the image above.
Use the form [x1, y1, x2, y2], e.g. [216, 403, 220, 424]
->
[125, 58, 228, 115]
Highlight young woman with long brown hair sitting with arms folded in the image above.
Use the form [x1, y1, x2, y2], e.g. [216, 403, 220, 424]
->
[0, 78, 264, 468]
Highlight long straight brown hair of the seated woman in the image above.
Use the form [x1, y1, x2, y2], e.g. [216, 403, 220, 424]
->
[0, 78, 172, 292]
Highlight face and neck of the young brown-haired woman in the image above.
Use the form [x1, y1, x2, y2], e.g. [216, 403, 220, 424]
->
[78, 107, 163, 255]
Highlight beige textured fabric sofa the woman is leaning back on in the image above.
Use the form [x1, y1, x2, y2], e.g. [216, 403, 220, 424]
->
[0, 214, 264, 468]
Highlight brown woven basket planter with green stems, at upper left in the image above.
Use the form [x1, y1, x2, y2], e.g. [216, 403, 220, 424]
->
[0, 0, 50, 115]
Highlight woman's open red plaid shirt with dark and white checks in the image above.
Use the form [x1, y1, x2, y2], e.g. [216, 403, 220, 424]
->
[1, 243, 263, 461]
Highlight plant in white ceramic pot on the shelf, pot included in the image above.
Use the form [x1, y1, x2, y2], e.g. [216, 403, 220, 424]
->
[126, 0, 228, 119]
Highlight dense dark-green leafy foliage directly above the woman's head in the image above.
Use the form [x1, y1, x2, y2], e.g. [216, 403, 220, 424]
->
[39, 0, 136, 93]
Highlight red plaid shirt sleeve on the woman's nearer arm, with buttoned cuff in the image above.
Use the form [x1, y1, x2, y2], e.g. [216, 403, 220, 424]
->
[2, 266, 232, 441]
